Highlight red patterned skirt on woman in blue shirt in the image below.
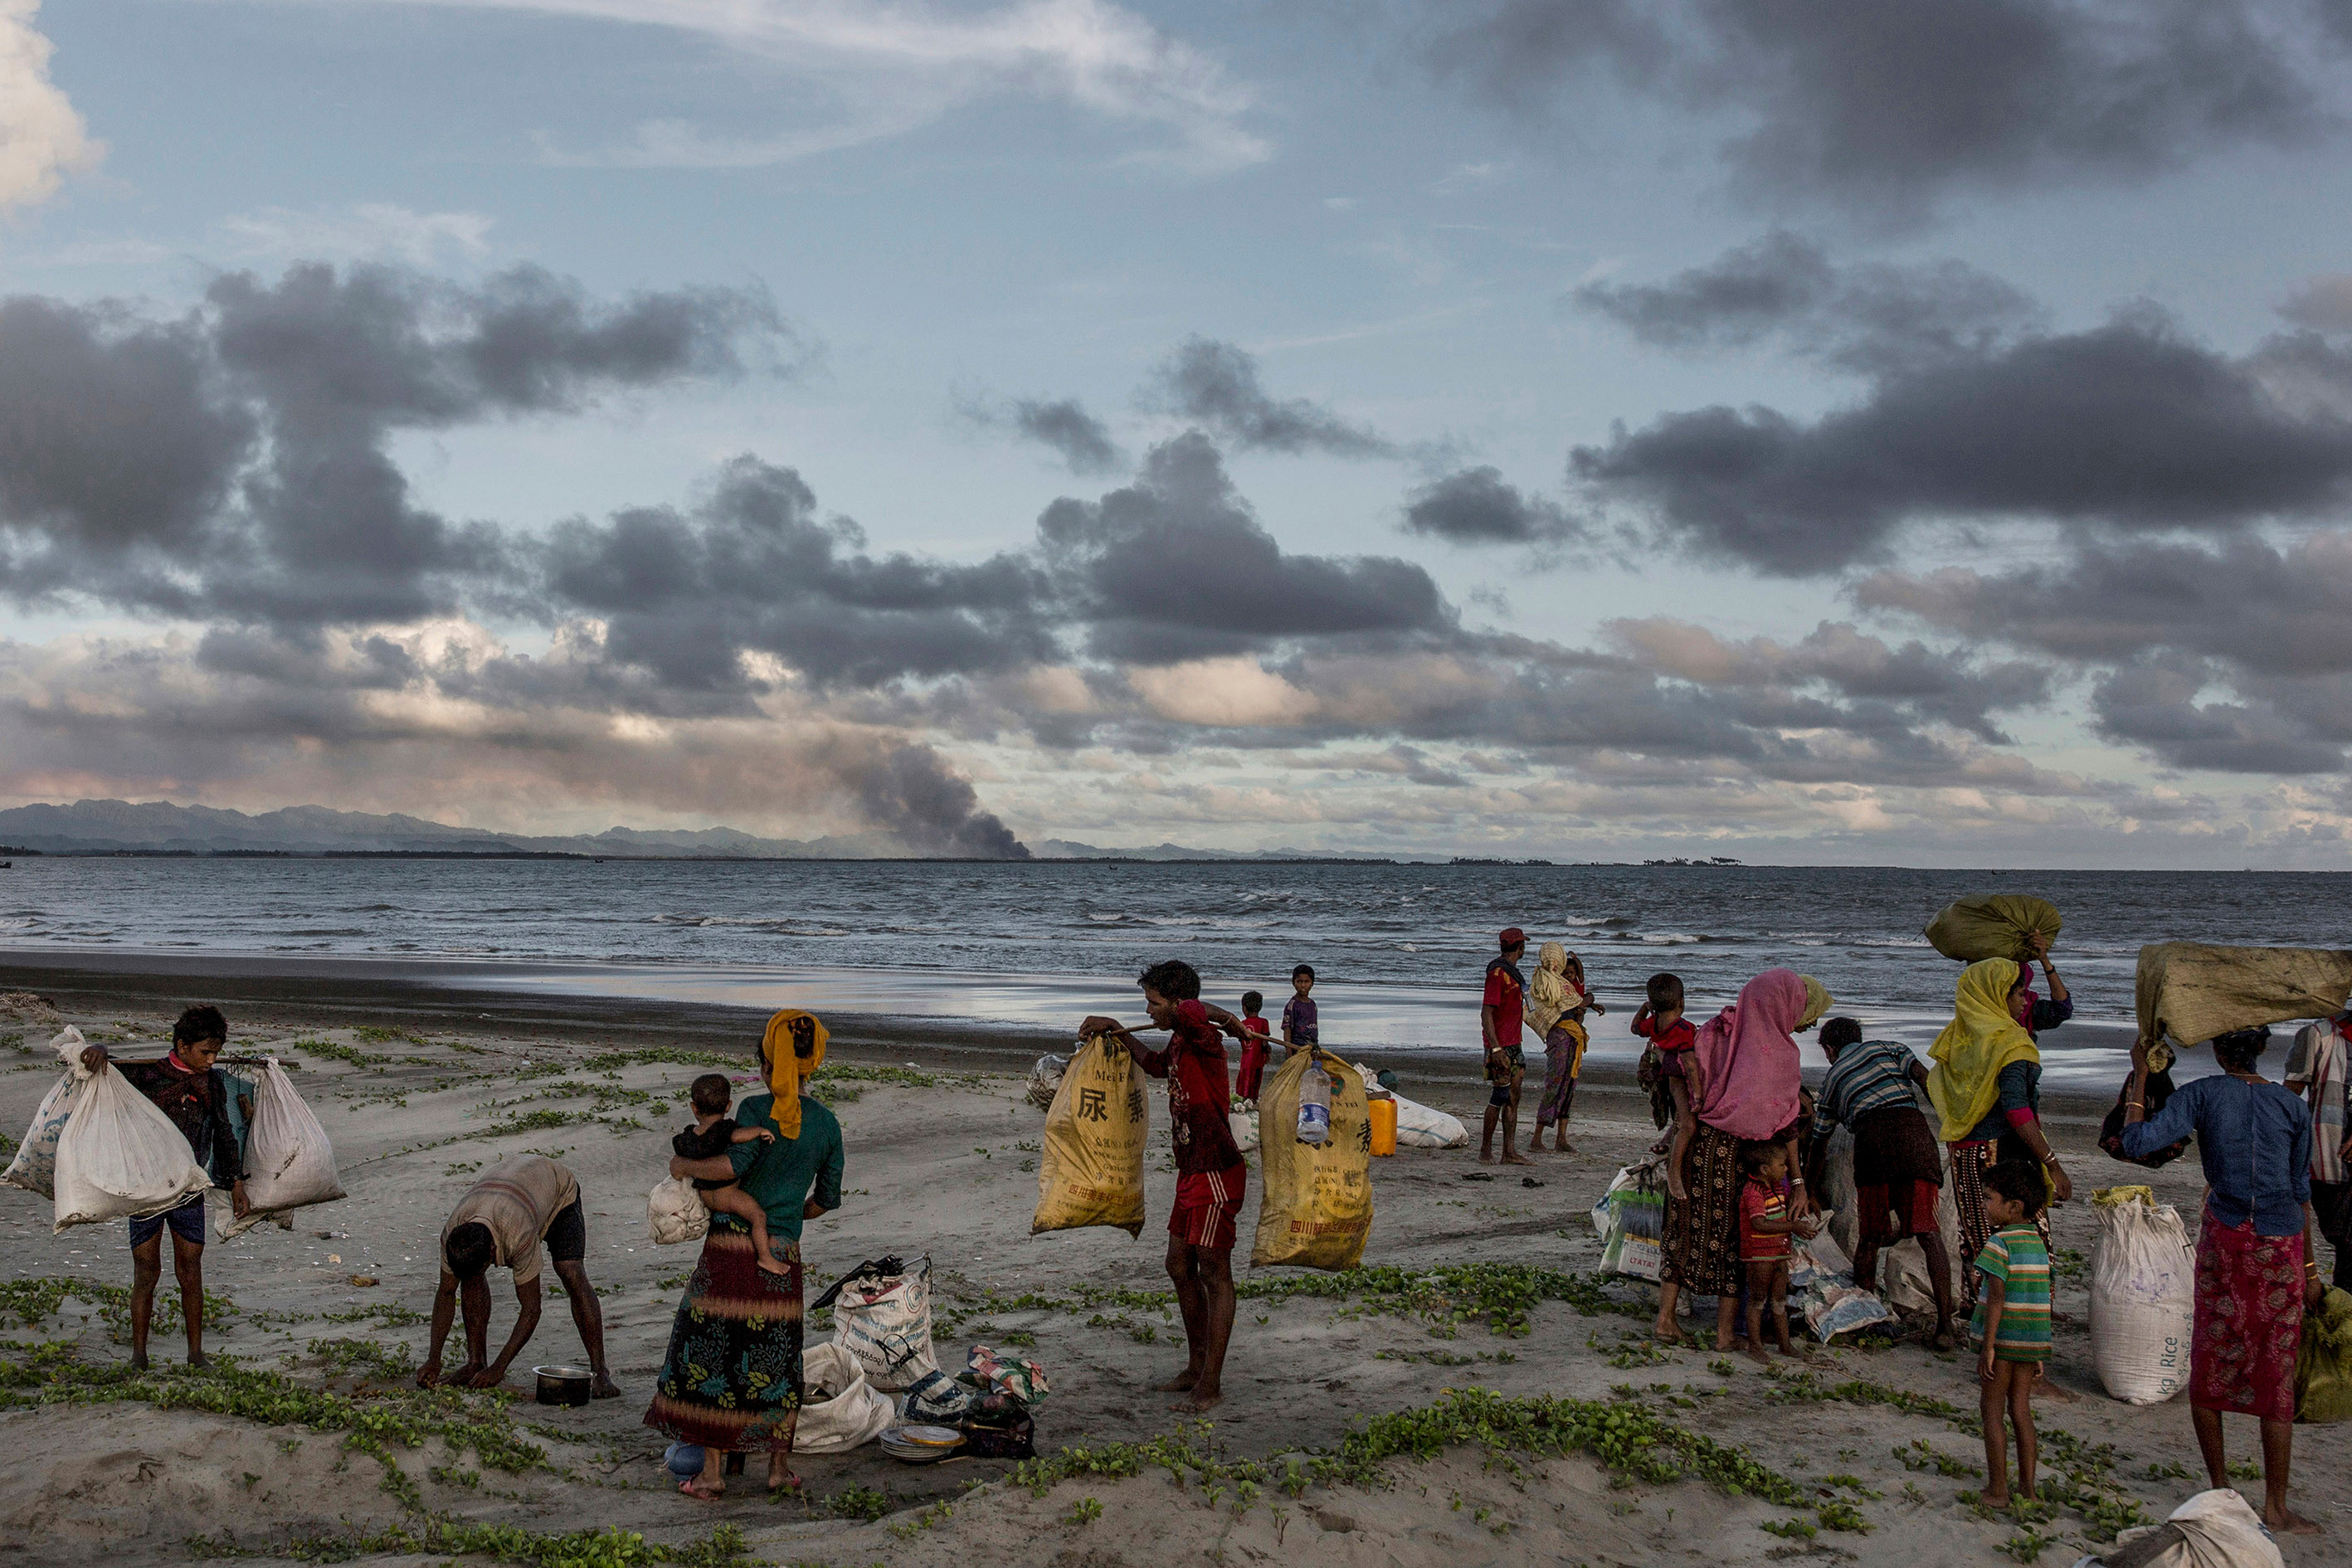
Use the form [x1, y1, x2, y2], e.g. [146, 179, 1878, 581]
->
[2189, 1208, 2302, 1419]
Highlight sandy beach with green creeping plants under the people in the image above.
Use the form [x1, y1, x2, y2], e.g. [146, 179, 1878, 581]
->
[0, 959, 2352, 1568]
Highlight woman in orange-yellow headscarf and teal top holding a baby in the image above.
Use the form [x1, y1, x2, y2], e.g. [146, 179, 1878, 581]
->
[645, 1009, 842, 1500]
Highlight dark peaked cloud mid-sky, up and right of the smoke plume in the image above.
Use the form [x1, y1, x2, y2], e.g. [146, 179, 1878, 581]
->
[1037, 431, 1454, 663]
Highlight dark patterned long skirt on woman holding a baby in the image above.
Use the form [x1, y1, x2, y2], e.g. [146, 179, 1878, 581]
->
[645, 1213, 802, 1453]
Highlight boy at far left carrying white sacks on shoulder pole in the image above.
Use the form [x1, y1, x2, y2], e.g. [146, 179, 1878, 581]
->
[82, 1006, 250, 1368]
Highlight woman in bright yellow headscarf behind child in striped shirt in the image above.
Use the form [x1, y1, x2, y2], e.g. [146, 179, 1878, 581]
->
[1926, 959, 2074, 1312]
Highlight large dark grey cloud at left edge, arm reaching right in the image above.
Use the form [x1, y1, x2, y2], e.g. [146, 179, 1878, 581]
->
[0, 263, 788, 626]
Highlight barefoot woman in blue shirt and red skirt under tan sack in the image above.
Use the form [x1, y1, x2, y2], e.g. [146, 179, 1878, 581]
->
[2124, 1027, 2321, 1535]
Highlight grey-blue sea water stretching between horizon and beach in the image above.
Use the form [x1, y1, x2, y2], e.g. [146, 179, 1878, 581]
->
[0, 855, 2352, 1086]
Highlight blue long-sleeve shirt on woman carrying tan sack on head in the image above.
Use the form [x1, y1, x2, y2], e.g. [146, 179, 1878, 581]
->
[2124, 1074, 2312, 1236]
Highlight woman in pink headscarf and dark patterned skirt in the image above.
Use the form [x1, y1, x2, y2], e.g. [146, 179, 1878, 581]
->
[1658, 968, 1830, 1349]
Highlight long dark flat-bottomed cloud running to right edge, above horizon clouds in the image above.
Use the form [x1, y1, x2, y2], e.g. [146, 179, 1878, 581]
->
[1569, 308, 2352, 576]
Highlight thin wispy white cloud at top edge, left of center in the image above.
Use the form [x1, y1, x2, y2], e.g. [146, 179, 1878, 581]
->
[385, 0, 1270, 174]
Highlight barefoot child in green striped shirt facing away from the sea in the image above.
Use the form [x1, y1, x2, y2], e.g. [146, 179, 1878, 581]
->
[1971, 1159, 2051, 1509]
